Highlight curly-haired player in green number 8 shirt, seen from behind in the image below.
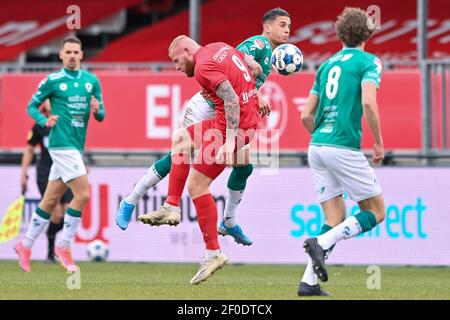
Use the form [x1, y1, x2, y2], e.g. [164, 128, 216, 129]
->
[298, 8, 385, 296]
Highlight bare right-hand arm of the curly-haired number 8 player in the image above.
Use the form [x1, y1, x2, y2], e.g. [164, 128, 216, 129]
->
[361, 81, 384, 163]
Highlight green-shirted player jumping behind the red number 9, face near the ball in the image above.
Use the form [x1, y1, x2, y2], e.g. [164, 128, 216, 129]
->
[116, 8, 291, 245]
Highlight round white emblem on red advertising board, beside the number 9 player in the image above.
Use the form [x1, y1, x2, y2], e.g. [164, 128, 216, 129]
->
[257, 81, 289, 143]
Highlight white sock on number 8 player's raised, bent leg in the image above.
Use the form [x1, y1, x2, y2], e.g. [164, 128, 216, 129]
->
[317, 216, 362, 250]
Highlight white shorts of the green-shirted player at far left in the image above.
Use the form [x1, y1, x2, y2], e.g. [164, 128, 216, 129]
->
[48, 149, 87, 183]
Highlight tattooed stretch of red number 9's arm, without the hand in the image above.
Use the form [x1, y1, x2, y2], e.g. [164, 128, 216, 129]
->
[216, 80, 240, 140]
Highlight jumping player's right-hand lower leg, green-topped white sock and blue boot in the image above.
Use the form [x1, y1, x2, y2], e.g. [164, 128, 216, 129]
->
[218, 164, 253, 246]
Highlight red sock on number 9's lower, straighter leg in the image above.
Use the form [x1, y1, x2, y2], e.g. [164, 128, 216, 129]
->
[192, 194, 220, 250]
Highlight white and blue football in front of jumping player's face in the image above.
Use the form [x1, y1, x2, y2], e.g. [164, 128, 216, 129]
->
[272, 43, 303, 76]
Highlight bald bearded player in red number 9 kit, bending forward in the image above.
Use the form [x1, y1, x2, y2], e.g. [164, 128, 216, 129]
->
[139, 36, 262, 284]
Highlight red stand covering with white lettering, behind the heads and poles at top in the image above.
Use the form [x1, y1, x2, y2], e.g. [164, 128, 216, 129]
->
[91, 0, 450, 63]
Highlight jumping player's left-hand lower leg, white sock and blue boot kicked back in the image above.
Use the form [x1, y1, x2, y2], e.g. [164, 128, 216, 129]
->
[116, 152, 172, 230]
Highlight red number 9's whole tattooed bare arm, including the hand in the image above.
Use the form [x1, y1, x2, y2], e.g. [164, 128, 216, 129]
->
[216, 80, 241, 163]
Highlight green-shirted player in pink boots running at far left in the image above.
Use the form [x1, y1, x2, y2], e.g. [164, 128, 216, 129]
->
[15, 37, 105, 272]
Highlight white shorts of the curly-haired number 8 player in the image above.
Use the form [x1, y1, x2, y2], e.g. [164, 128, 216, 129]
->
[308, 145, 381, 203]
